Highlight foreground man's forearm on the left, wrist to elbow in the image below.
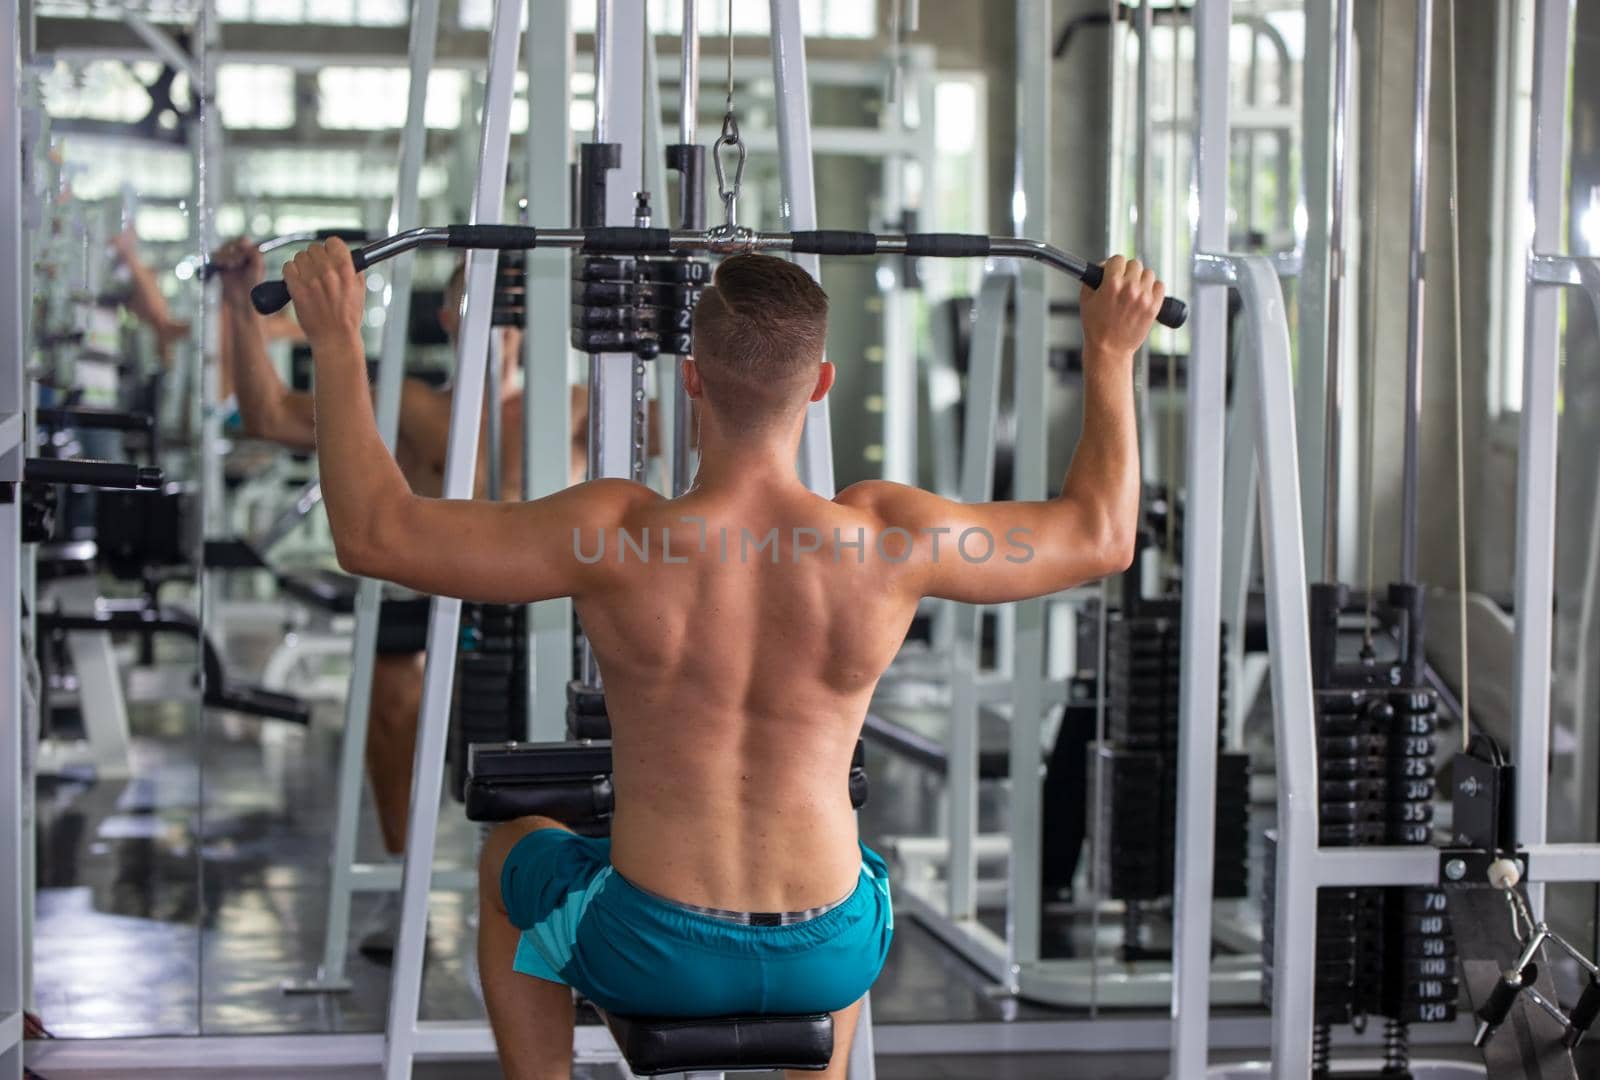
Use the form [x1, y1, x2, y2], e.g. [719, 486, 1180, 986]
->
[310, 330, 411, 566]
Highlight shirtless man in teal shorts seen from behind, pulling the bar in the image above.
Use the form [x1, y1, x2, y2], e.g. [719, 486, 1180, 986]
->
[285, 240, 1163, 1080]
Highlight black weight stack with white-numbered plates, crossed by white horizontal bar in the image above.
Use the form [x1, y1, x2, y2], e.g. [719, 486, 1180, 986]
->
[1262, 584, 1459, 1077]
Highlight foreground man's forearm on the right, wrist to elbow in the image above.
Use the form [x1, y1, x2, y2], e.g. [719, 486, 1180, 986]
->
[1059, 347, 1139, 550]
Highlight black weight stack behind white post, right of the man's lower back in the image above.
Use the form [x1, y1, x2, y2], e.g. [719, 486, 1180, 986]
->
[1090, 600, 1250, 901]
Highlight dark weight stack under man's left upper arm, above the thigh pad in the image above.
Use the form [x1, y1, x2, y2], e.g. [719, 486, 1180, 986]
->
[450, 603, 528, 802]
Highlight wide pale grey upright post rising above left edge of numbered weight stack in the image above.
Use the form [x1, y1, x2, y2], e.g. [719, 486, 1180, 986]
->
[1294, 0, 1352, 576]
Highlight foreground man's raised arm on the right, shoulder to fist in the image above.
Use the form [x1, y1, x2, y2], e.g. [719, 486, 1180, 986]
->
[840, 256, 1165, 603]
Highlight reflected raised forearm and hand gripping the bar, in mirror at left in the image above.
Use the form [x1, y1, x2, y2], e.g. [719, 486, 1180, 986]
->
[214, 240, 317, 450]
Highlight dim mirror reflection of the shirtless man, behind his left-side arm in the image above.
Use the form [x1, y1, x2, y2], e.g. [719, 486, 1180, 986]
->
[213, 238, 587, 960]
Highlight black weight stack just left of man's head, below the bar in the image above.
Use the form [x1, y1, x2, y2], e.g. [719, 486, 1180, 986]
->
[573, 256, 710, 360]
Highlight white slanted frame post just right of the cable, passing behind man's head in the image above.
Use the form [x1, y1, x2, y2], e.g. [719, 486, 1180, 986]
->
[768, 0, 834, 499]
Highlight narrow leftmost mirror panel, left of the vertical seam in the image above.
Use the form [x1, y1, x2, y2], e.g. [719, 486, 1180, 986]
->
[21, 36, 208, 1038]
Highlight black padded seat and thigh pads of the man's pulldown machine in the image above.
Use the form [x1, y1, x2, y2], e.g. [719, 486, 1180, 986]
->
[466, 741, 867, 1080]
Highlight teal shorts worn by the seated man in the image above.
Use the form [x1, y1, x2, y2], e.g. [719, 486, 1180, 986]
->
[501, 829, 894, 1016]
